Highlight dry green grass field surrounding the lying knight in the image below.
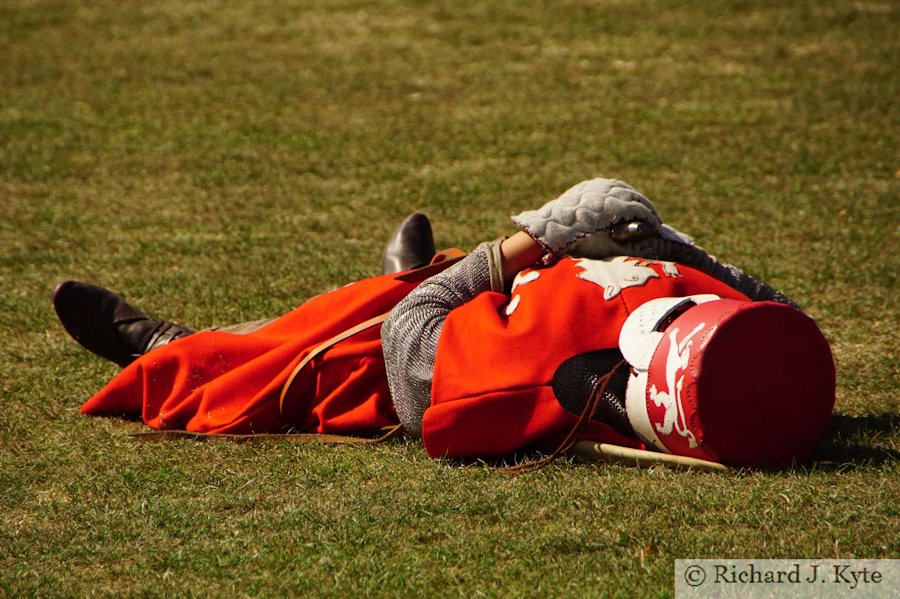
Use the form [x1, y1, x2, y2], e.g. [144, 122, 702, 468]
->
[0, 0, 900, 597]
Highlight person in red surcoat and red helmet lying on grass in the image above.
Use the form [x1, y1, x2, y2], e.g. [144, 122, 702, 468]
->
[53, 179, 835, 467]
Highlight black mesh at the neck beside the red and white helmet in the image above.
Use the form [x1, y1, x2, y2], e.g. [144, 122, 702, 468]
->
[552, 349, 634, 435]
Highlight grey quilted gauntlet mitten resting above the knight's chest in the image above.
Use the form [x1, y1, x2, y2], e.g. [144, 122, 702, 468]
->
[512, 179, 693, 264]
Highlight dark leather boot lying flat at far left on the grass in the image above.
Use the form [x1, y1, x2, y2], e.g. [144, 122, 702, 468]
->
[53, 281, 194, 368]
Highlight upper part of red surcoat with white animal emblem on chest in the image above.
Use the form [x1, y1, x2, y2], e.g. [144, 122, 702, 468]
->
[422, 258, 747, 457]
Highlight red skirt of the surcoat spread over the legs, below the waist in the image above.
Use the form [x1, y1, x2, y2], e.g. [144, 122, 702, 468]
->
[81, 275, 417, 434]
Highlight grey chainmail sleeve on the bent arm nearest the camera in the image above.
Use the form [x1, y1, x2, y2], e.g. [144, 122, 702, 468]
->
[381, 244, 502, 437]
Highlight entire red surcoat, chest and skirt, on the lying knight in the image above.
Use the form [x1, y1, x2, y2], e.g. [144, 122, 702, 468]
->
[82, 259, 746, 457]
